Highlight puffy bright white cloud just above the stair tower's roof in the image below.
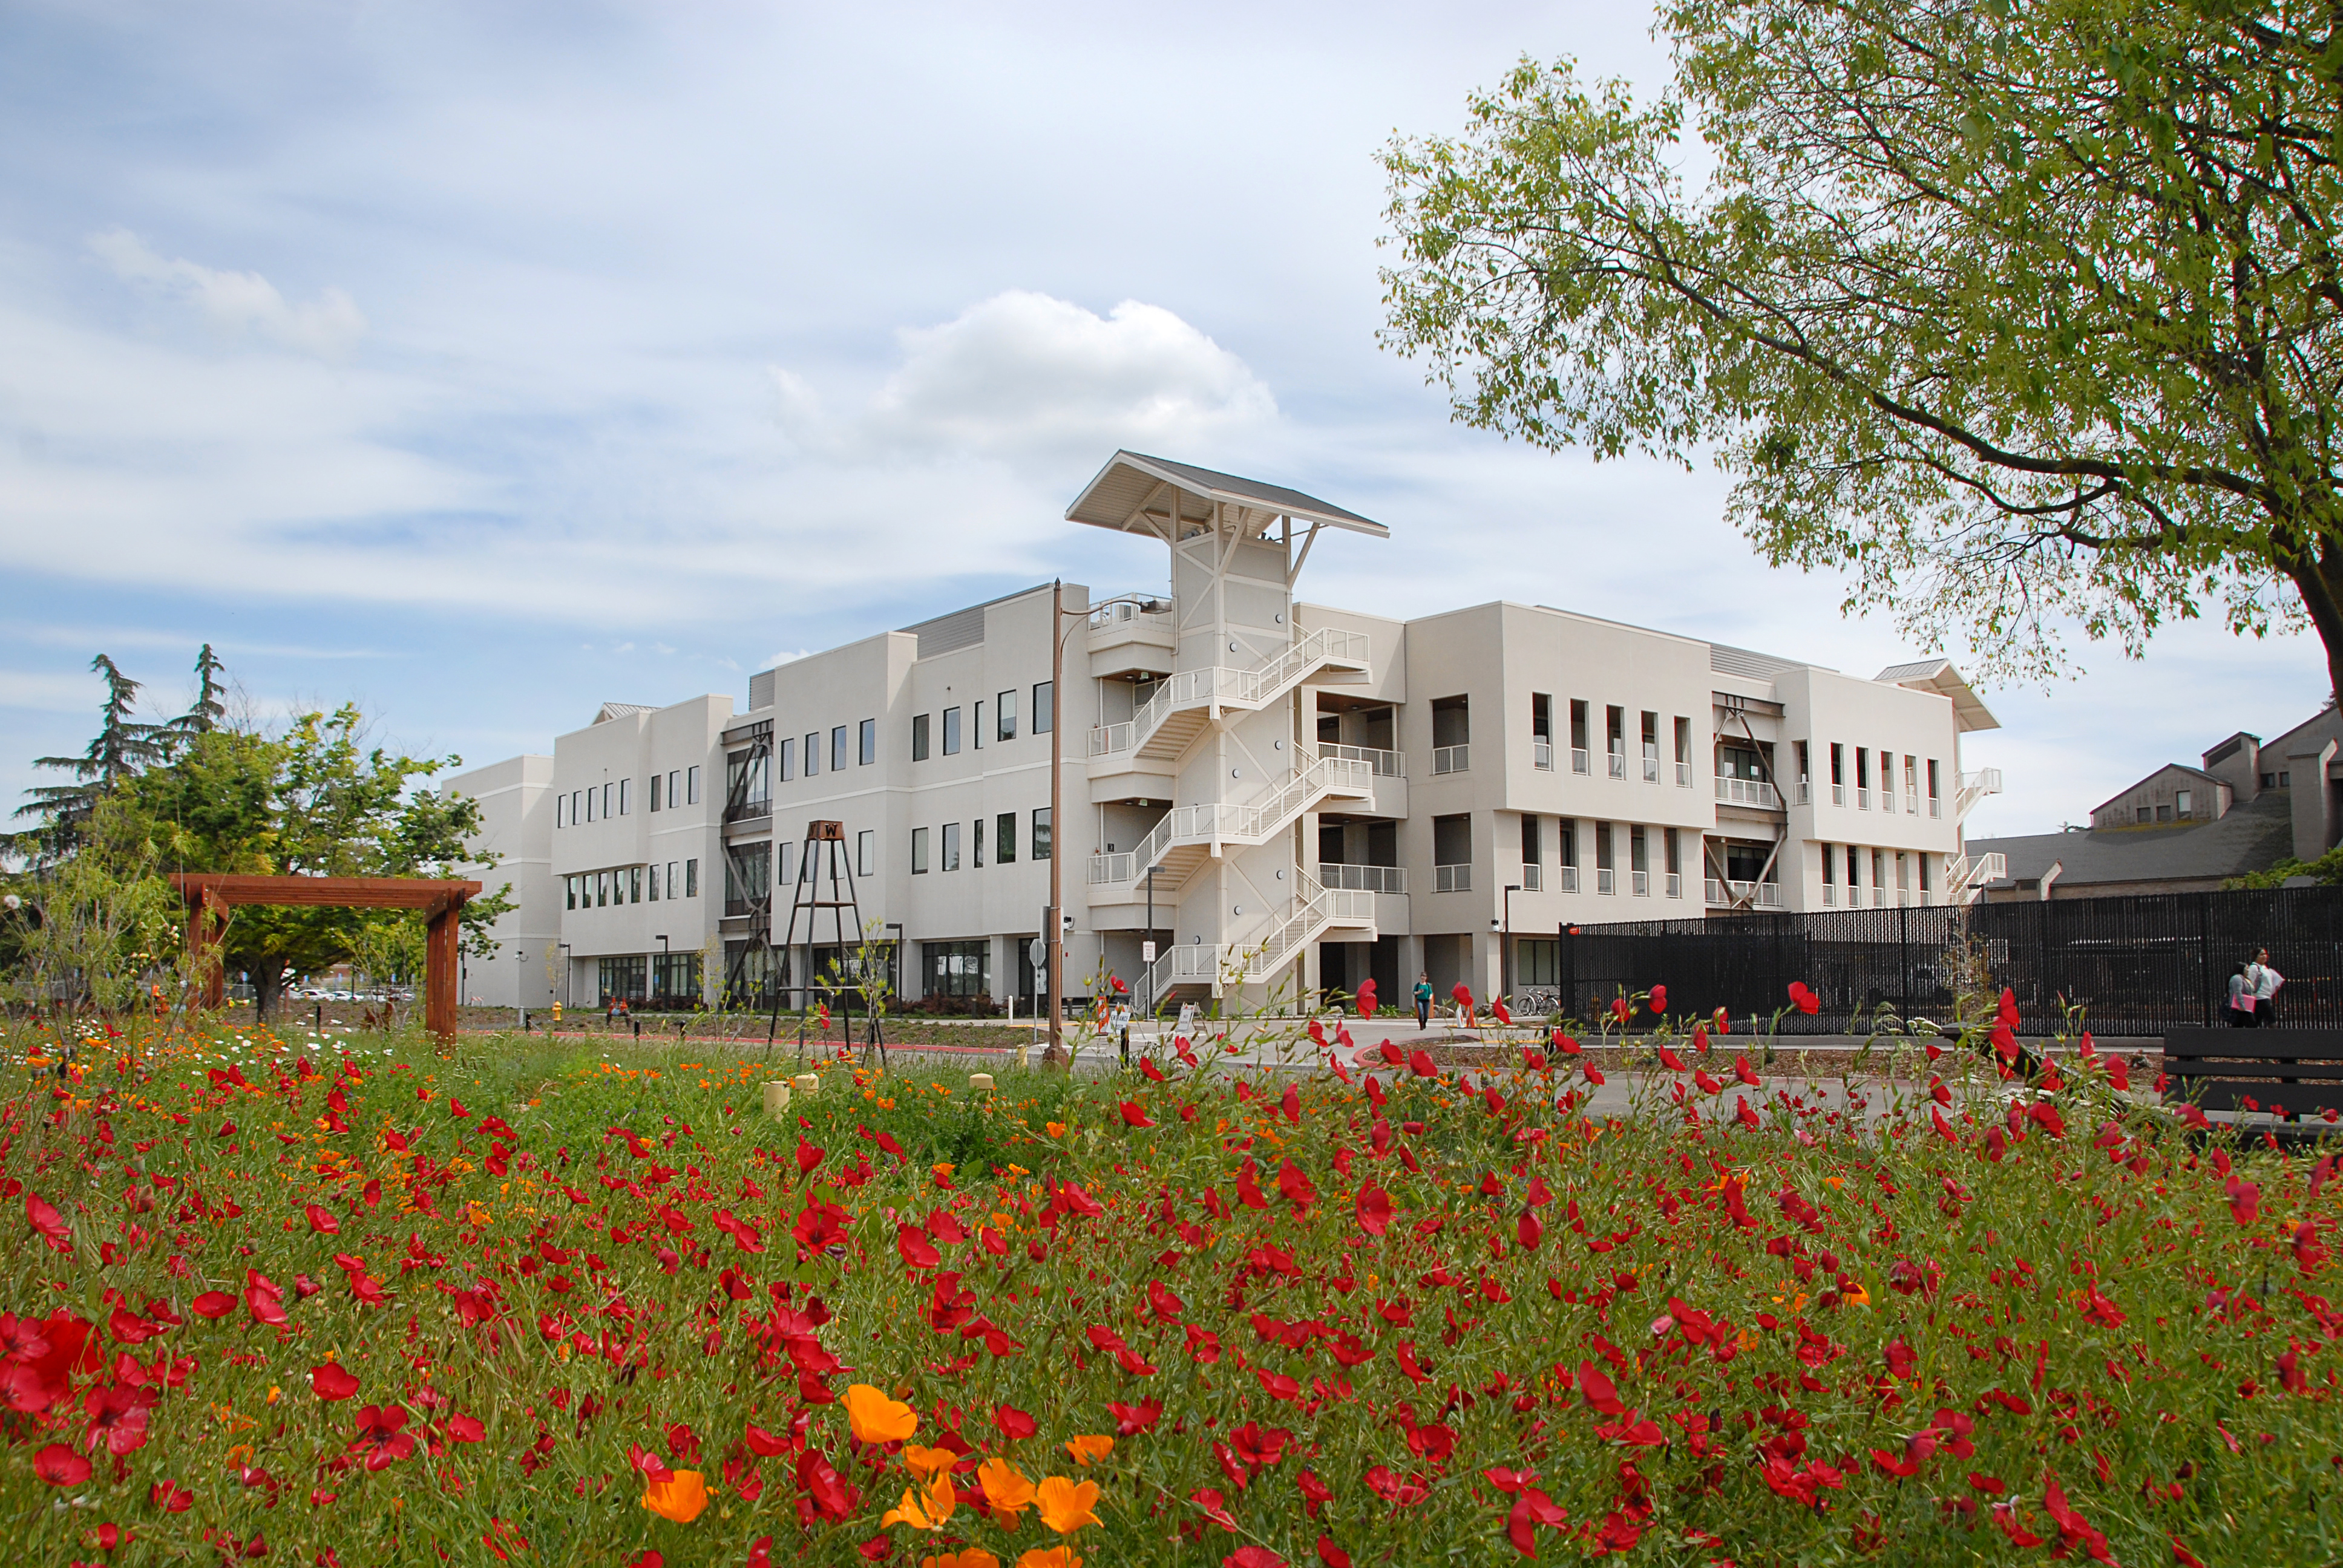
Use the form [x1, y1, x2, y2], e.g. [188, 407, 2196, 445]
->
[771, 289, 1277, 464]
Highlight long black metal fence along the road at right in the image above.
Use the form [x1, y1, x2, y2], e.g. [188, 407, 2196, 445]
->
[1558, 888, 2343, 1036]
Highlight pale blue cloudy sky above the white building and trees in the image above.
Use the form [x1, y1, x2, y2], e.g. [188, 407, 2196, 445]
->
[0, 0, 2324, 832]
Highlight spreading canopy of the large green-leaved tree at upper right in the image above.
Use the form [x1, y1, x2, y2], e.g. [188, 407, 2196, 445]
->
[1384, 0, 2343, 689]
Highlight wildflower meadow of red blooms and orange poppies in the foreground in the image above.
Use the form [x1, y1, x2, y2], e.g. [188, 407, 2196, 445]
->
[0, 999, 2343, 1568]
